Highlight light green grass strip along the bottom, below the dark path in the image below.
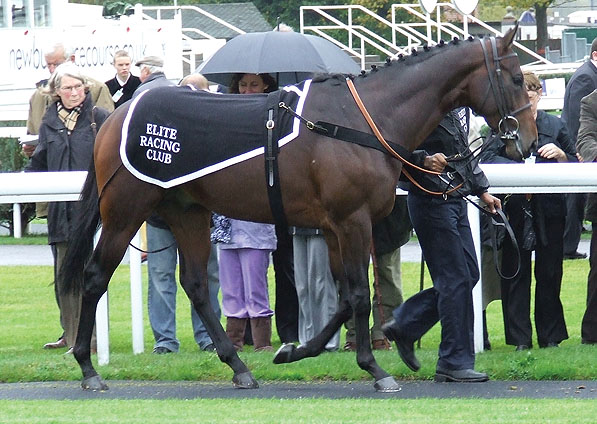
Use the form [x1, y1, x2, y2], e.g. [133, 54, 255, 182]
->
[0, 399, 597, 424]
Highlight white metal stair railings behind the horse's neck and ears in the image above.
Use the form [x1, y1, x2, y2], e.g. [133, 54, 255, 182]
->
[300, 3, 551, 68]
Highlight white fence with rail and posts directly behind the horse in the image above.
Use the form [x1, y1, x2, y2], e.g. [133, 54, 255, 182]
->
[0, 163, 597, 364]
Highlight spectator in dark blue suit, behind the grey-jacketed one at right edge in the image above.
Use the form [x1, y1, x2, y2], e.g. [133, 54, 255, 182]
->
[562, 38, 597, 259]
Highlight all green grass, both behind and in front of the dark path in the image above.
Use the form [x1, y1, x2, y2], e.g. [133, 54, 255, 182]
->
[0, 261, 597, 424]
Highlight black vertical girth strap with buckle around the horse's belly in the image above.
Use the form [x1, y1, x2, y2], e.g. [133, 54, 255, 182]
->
[264, 91, 288, 231]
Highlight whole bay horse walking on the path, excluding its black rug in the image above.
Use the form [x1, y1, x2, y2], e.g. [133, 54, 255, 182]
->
[63, 24, 537, 392]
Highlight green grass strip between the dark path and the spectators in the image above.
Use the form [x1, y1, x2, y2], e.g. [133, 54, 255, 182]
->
[0, 260, 597, 382]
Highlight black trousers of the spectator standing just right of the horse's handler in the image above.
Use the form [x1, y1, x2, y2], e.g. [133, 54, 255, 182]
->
[502, 202, 568, 347]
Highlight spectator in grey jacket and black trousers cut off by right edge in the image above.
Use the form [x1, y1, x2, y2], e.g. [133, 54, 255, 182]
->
[576, 90, 597, 344]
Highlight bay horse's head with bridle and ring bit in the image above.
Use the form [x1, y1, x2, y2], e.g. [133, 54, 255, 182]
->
[471, 23, 537, 160]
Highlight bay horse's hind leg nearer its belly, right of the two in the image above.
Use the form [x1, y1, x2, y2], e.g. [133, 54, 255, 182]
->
[165, 205, 259, 389]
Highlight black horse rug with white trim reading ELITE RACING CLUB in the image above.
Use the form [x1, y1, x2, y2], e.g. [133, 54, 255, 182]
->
[120, 80, 311, 188]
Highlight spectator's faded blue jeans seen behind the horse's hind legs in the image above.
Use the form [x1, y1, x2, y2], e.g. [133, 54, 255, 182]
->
[147, 224, 221, 352]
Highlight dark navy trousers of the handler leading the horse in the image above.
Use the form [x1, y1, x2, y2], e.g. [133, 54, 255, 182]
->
[393, 193, 479, 370]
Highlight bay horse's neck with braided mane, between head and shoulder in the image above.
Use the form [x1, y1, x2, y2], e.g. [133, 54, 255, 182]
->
[363, 41, 481, 150]
